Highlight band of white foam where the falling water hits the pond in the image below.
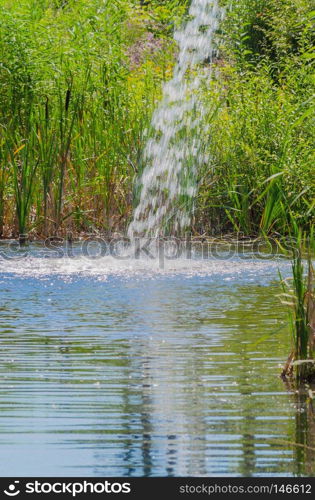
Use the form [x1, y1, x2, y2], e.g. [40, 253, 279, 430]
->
[0, 256, 289, 281]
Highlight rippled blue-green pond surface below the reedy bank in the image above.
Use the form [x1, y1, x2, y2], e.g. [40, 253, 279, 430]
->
[0, 248, 315, 476]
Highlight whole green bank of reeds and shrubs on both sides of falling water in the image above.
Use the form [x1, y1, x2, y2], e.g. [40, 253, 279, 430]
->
[0, 0, 315, 238]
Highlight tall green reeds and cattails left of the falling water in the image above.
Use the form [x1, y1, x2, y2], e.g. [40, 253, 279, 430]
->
[0, 0, 187, 237]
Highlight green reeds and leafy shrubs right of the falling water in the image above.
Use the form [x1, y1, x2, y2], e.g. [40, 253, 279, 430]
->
[194, 0, 315, 235]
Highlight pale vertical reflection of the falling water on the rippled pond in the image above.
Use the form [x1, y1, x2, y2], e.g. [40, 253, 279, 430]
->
[124, 337, 207, 476]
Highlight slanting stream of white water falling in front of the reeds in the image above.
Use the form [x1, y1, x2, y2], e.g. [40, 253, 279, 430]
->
[128, 0, 223, 239]
